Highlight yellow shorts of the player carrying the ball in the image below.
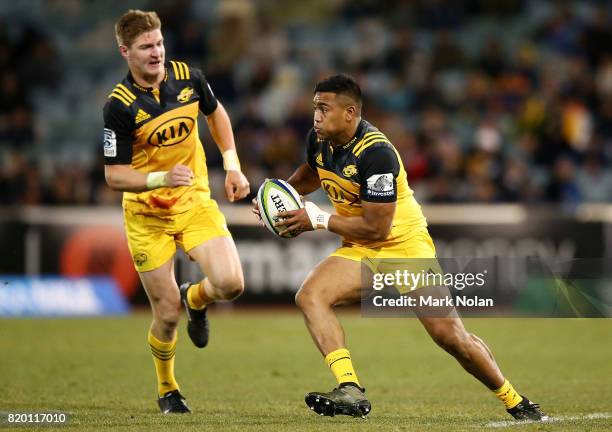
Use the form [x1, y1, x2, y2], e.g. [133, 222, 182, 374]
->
[330, 228, 443, 294]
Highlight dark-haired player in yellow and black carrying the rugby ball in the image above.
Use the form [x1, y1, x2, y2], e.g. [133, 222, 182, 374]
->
[254, 75, 547, 420]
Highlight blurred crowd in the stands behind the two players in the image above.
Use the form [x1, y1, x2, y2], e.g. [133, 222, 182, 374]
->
[0, 0, 612, 207]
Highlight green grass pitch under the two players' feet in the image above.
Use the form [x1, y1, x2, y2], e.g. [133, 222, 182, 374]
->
[0, 310, 612, 432]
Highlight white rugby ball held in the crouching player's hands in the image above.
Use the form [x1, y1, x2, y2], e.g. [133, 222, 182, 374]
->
[257, 179, 304, 235]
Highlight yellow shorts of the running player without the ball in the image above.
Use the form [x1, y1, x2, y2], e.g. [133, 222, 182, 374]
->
[123, 199, 231, 272]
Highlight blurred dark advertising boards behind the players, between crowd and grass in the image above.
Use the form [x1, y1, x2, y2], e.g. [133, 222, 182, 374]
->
[0, 204, 612, 315]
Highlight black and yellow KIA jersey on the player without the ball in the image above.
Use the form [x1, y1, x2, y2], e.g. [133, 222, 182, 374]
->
[104, 61, 218, 216]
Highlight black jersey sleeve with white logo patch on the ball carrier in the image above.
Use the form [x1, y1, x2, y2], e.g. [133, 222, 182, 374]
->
[357, 147, 400, 203]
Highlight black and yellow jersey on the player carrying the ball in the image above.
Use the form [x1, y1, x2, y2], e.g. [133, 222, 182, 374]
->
[307, 120, 427, 248]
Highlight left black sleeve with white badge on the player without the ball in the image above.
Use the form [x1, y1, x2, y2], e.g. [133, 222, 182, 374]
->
[104, 99, 134, 165]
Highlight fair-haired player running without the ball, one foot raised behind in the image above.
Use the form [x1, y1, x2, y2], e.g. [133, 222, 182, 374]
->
[104, 10, 249, 413]
